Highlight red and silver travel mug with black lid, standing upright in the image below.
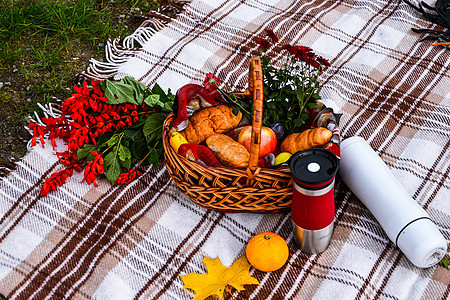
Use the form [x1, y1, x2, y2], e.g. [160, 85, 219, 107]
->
[289, 148, 339, 254]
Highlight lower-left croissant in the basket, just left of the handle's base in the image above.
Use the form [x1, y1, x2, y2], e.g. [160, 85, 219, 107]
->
[206, 134, 250, 168]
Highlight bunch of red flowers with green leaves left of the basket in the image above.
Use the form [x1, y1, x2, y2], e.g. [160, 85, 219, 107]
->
[29, 77, 174, 196]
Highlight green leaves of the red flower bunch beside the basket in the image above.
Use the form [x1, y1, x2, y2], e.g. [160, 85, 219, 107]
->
[77, 77, 175, 184]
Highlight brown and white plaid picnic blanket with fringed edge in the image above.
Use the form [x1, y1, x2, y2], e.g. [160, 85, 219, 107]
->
[0, 0, 450, 299]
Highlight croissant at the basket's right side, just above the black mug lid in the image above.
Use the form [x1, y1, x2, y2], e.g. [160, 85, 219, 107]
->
[280, 127, 333, 154]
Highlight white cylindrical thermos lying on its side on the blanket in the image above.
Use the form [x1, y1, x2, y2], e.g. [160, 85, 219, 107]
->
[339, 136, 447, 268]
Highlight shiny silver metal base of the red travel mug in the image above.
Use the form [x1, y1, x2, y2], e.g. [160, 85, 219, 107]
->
[292, 221, 334, 254]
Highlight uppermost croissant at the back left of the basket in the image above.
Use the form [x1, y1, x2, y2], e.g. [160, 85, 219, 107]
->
[181, 104, 242, 144]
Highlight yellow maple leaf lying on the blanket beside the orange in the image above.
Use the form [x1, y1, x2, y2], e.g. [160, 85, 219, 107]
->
[180, 256, 259, 300]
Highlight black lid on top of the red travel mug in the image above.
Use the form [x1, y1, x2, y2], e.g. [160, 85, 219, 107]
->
[289, 148, 339, 186]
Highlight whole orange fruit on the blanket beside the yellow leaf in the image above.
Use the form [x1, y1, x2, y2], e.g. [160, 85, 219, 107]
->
[245, 232, 289, 272]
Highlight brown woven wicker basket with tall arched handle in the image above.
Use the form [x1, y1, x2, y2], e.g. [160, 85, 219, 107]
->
[163, 57, 293, 213]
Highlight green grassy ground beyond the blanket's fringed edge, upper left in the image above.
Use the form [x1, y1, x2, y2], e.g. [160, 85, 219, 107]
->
[0, 0, 160, 117]
